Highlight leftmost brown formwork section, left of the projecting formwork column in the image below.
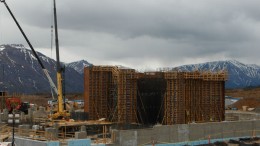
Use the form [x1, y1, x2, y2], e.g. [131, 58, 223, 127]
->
[84, 66, 117, 120]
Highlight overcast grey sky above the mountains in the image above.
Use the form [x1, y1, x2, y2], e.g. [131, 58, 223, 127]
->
[0, 0, 260, 70]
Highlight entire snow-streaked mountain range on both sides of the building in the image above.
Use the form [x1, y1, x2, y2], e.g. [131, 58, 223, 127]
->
[0, 44, 260, 93]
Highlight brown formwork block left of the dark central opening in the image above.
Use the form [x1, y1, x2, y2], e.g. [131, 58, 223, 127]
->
[84, 66, 138, 123]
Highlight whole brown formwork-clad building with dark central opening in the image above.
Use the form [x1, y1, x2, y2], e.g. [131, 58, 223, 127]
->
[84, 66, 227, 125]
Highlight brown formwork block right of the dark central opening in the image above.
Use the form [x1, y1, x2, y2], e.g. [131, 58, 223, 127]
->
[163, 71, 227, 125]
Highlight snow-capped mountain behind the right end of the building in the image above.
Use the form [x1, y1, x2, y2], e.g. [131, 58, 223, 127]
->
[175, 60, 260, 88]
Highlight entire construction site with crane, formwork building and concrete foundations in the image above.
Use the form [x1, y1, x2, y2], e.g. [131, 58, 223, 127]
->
[0, 0, 260, 146]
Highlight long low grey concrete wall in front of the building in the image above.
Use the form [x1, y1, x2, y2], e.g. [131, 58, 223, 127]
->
[113, 120, 260, 146]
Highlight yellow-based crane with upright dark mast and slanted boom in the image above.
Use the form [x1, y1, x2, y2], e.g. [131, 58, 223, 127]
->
[0, 0, 70, 119]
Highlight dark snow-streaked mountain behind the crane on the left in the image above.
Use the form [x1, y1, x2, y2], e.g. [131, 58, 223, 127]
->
[0, 44, 83, 93]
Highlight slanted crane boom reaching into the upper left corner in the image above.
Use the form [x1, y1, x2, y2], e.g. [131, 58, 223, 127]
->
[0, 0, 58, 95]
